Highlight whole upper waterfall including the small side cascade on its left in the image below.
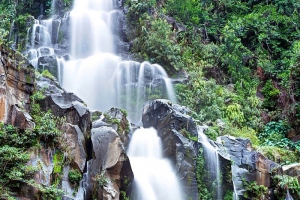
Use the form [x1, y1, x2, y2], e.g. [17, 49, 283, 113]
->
[28, 0, 175, 123]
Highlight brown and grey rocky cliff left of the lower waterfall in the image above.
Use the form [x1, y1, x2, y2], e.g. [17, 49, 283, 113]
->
[0, 46, 133, 199]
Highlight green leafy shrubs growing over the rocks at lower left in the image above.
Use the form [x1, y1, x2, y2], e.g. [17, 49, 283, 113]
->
[0, 83, 65, 199]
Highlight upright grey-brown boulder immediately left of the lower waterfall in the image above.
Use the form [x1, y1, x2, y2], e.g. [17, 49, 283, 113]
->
[86, 126, 133, 200]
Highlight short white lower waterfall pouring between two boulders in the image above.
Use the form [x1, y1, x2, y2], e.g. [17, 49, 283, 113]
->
[128, 128, 183, 200]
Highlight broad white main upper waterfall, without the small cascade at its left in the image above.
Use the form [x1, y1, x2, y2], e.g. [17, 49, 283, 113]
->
[62, 0, 175, 123]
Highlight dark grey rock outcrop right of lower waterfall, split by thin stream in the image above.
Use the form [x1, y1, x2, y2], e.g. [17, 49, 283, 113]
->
[142, 100, 284, 199]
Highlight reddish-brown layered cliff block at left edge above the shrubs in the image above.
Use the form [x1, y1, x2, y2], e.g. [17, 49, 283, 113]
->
[0, 45, 35, 129]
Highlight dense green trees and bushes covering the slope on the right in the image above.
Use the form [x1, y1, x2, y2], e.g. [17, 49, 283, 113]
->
[126, 0, 300, 164]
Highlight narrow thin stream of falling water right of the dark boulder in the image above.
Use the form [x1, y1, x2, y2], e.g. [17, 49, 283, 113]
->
[197, 126, 222, 199]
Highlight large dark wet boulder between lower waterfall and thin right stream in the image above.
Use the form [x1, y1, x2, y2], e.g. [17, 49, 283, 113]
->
[142, 99, 198, 199]
